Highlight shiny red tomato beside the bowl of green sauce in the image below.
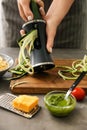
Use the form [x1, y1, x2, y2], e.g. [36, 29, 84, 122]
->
[71, 87, 86, 101]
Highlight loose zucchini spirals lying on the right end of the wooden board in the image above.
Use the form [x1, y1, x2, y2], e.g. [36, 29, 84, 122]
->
[56, 55, 87, 80]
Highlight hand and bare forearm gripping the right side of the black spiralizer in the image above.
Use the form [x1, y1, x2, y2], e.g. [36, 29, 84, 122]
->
[45, 0, 74, 52]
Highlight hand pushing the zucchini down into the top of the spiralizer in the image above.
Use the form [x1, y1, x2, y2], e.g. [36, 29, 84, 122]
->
[17, 0, 45, 21]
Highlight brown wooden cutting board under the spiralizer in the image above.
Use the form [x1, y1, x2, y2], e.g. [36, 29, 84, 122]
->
[10, 59, 87, 94]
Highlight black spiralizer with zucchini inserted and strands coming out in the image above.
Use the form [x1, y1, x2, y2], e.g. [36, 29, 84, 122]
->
[10, 0, 54, 77]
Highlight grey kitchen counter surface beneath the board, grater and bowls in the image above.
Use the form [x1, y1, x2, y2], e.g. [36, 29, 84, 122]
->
[0, 48, 87, 130]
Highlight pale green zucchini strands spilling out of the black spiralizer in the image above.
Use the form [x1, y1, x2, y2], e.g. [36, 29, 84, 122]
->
[9, 29, 38, 79]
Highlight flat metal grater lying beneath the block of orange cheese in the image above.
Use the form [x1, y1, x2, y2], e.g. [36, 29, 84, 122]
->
[0, 93, 41, 118]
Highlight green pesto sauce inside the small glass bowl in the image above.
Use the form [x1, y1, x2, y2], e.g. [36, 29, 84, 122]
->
[47, 94, 72, 107]
